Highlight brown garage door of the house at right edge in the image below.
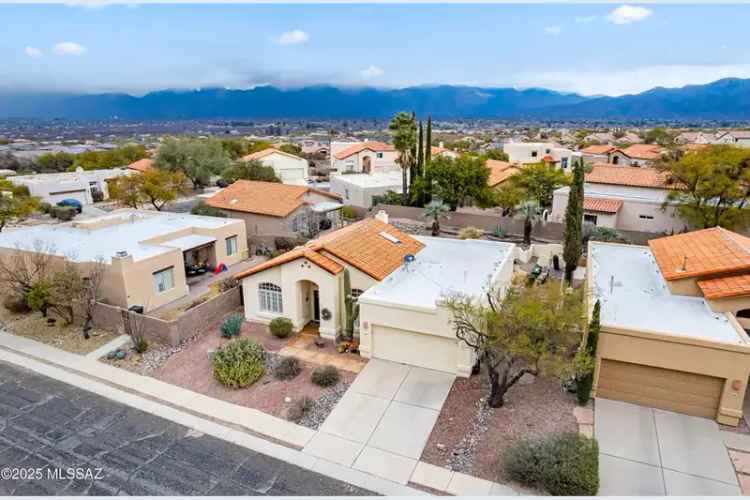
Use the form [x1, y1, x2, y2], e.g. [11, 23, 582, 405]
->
[596, 359, 724, 419]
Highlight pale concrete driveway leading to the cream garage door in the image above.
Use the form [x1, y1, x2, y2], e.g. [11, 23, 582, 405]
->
[305, 359, 455, 484]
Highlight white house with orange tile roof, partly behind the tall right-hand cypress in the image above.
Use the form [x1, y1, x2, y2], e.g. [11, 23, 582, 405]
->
[550, 164, 688, 233]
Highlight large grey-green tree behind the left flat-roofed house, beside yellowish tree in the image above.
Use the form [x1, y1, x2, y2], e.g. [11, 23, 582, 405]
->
[154, 138, 232, 189]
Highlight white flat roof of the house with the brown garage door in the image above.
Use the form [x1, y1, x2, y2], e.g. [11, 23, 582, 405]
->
[589, 243, 746, 344]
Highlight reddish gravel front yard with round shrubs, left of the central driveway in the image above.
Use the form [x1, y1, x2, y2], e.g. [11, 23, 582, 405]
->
[107, 312, 356, 422]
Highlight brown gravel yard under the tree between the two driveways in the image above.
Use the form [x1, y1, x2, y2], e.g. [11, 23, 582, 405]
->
[422, 373, 578, 482]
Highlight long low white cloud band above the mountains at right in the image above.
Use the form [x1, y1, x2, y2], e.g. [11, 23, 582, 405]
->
[511, 64, 750, 96]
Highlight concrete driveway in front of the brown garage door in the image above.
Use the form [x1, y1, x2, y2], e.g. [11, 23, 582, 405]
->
[594, 399, 741, 496]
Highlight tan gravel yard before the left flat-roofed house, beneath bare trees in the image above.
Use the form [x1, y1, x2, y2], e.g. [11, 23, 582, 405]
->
[0, 306, 117, 354]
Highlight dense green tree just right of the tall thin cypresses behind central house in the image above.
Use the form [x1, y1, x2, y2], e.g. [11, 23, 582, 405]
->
[420, 155, 494, 211]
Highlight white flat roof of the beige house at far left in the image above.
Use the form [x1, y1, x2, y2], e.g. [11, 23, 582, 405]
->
[0, 210, 241, 262]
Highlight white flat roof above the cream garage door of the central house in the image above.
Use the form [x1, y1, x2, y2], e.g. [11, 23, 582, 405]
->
[359, 236, 515, 309]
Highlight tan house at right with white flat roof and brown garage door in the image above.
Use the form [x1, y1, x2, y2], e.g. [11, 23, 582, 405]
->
[587, 228, 750, 426]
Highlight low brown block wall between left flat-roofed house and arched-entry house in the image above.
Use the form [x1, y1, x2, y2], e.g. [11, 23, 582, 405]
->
[94, 286, 242, 346]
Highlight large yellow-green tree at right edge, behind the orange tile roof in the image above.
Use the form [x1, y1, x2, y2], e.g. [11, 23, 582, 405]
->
[660, 146, 750, 229]
